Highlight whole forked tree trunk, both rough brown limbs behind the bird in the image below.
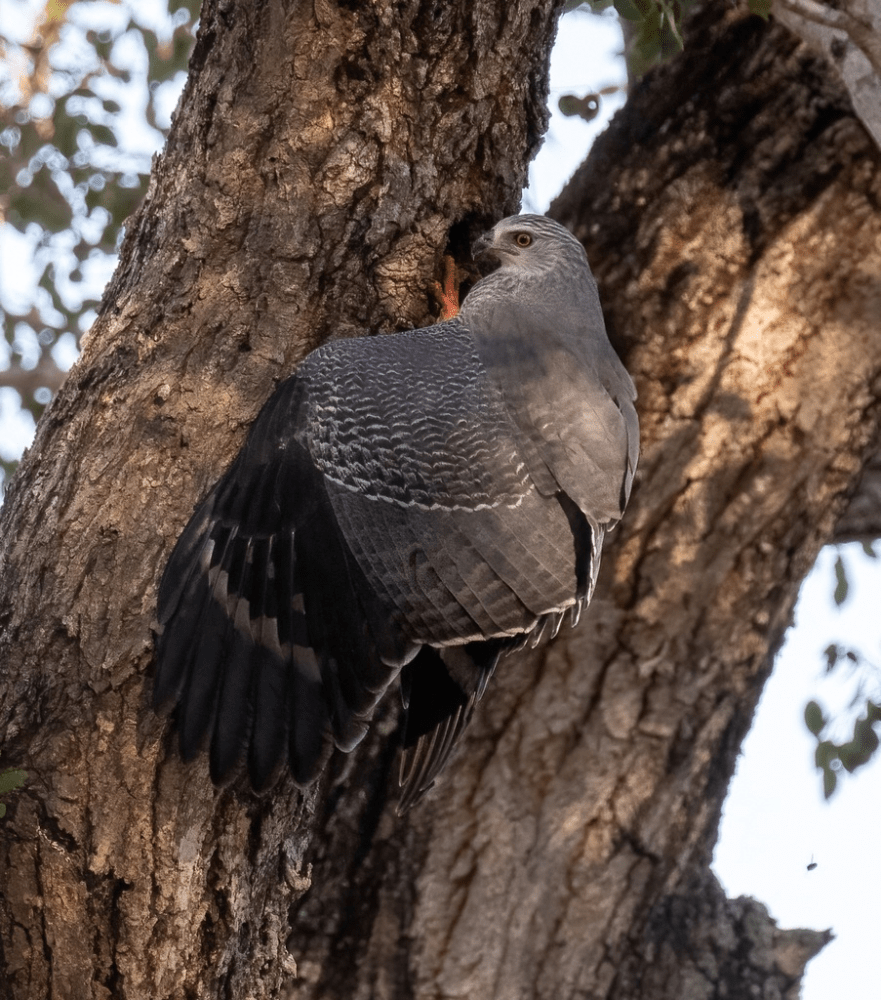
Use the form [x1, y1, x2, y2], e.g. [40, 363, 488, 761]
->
[0, 0, 881, 1000]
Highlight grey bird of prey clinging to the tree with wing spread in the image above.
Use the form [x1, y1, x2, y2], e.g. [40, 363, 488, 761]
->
[153, 215, 639, 813]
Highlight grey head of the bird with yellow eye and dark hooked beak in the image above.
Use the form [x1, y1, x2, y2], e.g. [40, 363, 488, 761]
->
[471, 215, 587, 272]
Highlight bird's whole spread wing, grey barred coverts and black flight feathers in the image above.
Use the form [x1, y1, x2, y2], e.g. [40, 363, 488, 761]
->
[155, 321, 596, 794]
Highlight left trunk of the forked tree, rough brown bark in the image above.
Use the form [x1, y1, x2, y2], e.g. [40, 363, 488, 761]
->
[0, 0, 559, 1000]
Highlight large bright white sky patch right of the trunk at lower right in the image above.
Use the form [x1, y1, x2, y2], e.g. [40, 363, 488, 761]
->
[713, 545, 881, 1000]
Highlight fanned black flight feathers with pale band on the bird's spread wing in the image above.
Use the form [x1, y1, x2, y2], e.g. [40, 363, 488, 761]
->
[154, 377, 417, 788]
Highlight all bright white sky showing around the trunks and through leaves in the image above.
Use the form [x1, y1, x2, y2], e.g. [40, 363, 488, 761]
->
[0, 0, 881, 1000]
